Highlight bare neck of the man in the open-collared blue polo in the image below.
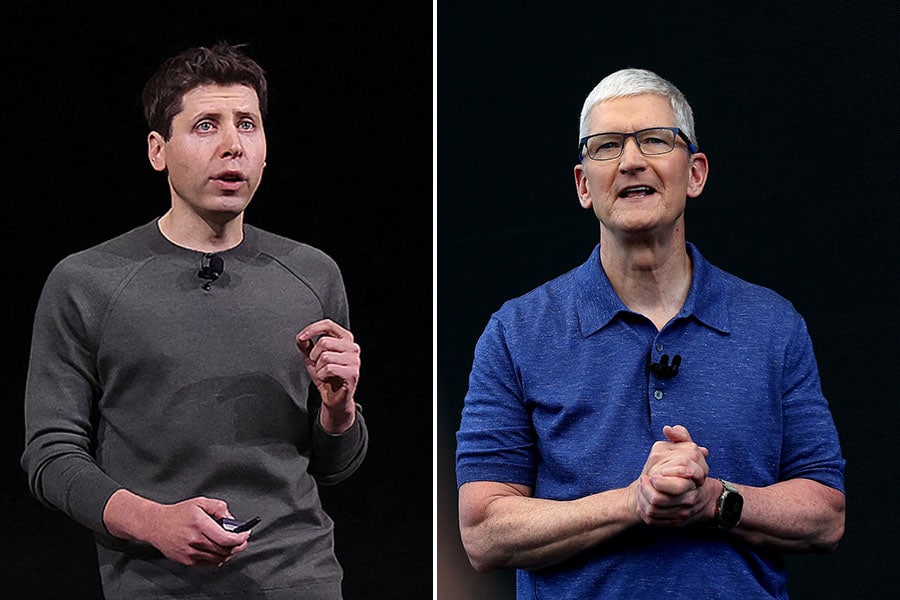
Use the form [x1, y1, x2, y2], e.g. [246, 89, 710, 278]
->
[600, 226, 693, 329]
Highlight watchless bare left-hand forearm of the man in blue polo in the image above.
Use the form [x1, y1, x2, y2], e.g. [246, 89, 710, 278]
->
[460, 482, 639, 572]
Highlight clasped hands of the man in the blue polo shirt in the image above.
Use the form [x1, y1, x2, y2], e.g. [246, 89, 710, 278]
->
[631, 425, 709, 527]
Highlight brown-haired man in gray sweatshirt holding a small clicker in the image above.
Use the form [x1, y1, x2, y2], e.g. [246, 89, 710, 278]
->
[22, 44, 368, 600]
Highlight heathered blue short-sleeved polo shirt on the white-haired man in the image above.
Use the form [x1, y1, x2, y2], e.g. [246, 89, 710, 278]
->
[457, 244, 844, 599]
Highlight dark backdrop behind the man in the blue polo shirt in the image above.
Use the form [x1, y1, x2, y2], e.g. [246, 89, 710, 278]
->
[437, 0, 900, 599]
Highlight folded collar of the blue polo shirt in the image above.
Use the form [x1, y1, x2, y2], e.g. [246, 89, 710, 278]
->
[575, 242, 731, 337]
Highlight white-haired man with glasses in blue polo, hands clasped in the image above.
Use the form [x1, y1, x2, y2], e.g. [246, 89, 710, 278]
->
[457, 69, 844, 599]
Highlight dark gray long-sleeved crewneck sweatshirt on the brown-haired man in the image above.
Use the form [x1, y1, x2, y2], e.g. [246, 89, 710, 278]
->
[22, 221, 368, 600]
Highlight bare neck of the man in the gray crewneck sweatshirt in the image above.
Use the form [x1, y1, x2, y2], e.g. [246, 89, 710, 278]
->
[159, 207, 244, 252]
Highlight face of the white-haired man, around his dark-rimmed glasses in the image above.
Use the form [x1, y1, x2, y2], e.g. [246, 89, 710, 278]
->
[575, 94, 708, 236]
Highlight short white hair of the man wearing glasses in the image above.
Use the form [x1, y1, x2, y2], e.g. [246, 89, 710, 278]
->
[578, 69, 697, 144]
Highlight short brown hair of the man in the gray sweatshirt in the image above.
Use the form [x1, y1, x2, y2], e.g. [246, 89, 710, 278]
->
[143, 42, 268, 140]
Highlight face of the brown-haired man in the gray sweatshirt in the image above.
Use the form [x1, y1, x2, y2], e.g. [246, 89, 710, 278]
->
[148, 85, 266, 221]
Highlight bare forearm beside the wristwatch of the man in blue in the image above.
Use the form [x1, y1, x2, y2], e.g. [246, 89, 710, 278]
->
[733, 479, 845, 553]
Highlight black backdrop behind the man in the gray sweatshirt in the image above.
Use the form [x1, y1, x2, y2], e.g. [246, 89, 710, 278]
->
[0, 1, 432, 600]
